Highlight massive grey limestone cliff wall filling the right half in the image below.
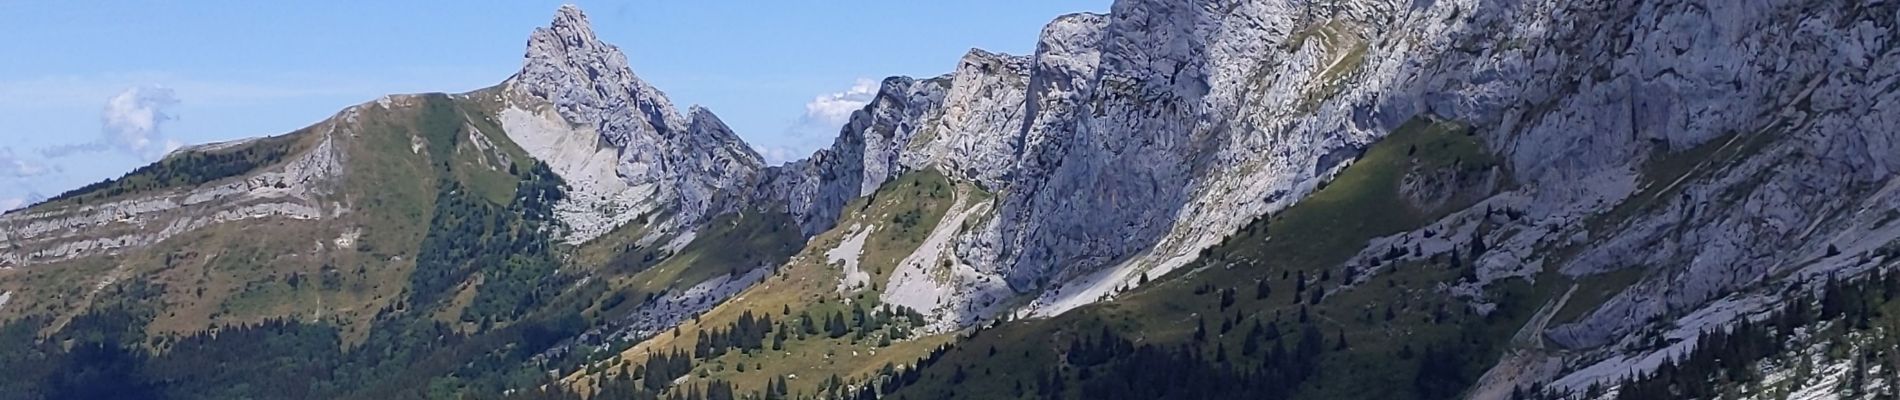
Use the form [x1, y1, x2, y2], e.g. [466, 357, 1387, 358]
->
[760, 0, 1900, 385]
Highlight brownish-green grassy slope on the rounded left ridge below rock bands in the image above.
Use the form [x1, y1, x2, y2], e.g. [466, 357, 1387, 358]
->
[0, 95, 551, 339]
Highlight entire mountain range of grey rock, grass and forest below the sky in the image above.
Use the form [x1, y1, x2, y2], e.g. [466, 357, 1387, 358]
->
[0, 0, 1900, 400]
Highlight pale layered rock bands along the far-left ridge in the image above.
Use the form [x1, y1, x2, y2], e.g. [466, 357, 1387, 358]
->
[0, 115, 353, 267]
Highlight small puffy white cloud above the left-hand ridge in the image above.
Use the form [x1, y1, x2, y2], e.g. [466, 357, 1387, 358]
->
[40, 87, 182, 161]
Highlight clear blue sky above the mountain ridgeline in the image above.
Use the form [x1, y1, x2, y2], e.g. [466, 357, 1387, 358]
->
[0, 0, 1108, 209]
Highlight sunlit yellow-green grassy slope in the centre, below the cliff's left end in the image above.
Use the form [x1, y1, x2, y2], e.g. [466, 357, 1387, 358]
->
[576, 171, 975, 392]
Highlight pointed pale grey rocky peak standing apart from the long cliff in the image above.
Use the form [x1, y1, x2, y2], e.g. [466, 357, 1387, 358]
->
[504, 6, 764, 243]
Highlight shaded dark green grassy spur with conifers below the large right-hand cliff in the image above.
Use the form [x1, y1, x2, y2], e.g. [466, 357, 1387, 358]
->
[903, 119, 1550, 398]
